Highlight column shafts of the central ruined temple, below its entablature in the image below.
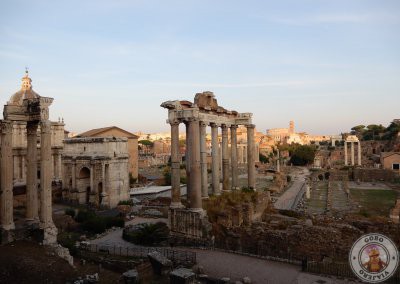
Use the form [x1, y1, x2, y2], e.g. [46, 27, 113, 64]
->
[171, 119, 255, 210]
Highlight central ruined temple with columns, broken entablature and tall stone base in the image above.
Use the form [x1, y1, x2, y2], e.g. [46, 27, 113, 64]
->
[161, 92, 255, 238]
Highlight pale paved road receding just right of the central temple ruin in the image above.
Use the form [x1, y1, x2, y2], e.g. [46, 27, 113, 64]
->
[274, 168, 309, 210]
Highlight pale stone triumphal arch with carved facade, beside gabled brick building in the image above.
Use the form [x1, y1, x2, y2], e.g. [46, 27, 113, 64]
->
[62, 137, 129, 208]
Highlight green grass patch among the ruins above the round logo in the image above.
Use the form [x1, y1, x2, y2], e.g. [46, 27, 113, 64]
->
[350, 188, 397, 217]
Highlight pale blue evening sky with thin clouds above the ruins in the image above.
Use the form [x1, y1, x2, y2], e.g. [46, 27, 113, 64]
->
[0, 0, 400, 134]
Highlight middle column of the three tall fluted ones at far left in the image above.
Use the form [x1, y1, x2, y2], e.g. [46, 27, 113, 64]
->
[26, 122, 39, 221]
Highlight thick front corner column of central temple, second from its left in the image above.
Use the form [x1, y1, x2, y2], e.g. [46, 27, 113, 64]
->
[189, 119, 202, 211]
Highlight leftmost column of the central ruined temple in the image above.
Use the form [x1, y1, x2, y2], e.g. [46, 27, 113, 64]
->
[170, 122, 182, 208]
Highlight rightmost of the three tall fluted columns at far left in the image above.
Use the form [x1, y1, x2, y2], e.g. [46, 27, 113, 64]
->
[40, 120, 54, 228]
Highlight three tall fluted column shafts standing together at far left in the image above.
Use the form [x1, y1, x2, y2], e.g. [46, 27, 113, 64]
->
[0, 120, 53, 230]
